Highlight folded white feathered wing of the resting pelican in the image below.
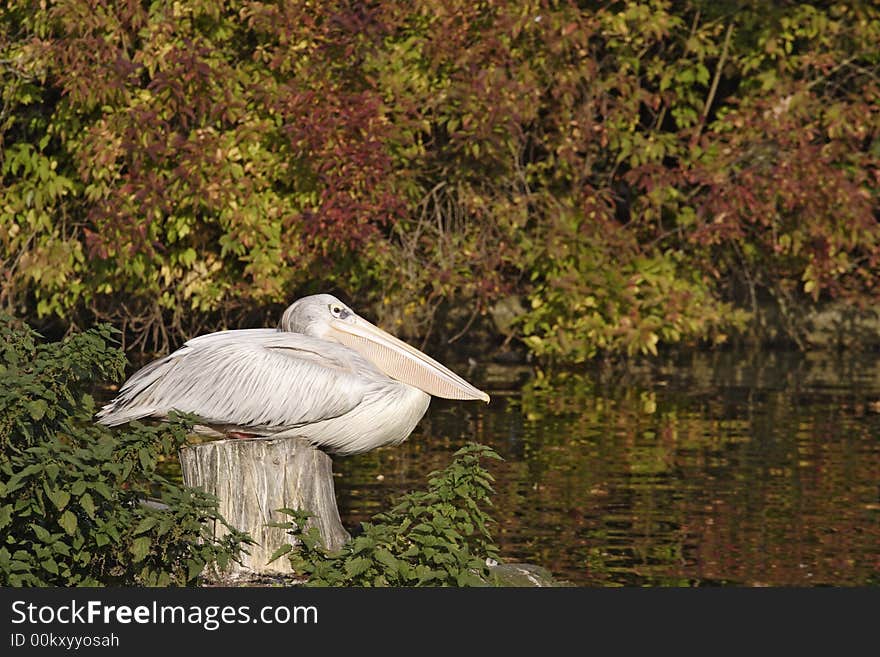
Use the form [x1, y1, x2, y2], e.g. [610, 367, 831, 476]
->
[97, 329, 385, 433]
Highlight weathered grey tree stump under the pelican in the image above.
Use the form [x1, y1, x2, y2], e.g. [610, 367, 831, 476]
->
[179, 438, 349, 577]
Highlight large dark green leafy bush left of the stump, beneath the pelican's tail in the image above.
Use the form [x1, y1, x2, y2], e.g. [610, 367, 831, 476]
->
[0, 316, 248, 586]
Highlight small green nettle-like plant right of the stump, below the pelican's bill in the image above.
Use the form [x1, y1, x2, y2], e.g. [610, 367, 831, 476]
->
[273, 444, 501, 586]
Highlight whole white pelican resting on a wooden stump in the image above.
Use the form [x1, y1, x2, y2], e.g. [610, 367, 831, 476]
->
[96, 294, 489, 455]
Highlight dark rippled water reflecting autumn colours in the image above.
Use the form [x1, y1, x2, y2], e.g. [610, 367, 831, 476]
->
[334, 352, 880, 586]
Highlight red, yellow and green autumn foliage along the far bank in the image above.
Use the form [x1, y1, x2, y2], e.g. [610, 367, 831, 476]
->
[0, 0, 880, 361]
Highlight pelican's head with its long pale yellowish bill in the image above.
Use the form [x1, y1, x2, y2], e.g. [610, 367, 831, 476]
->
[278, 294, 489, 402]
